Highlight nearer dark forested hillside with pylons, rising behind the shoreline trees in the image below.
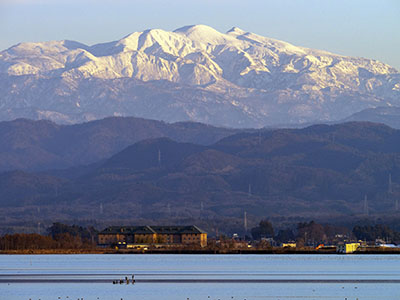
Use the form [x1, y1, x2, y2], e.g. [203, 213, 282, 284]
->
[0, 122, 400, 226]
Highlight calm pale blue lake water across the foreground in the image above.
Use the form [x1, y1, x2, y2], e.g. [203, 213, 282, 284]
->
[0, 255, 400, 300]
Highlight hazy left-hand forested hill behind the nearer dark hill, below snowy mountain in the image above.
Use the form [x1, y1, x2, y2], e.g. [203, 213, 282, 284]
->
[0, 117, 238, 171]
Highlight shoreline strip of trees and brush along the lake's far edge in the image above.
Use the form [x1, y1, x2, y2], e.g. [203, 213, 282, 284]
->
[0, 220, 400, 255]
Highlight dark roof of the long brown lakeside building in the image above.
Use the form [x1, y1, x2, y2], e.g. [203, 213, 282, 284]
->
[100, 225, 206, 234]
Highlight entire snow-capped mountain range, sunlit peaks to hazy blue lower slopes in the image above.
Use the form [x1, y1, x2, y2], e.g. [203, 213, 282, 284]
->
[0, 25, 400, 127]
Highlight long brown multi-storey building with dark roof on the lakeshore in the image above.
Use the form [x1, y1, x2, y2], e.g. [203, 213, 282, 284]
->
[98, 225, 207, 247]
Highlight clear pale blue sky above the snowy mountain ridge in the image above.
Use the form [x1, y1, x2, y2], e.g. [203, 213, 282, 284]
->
[0, 0, 400, 70]
